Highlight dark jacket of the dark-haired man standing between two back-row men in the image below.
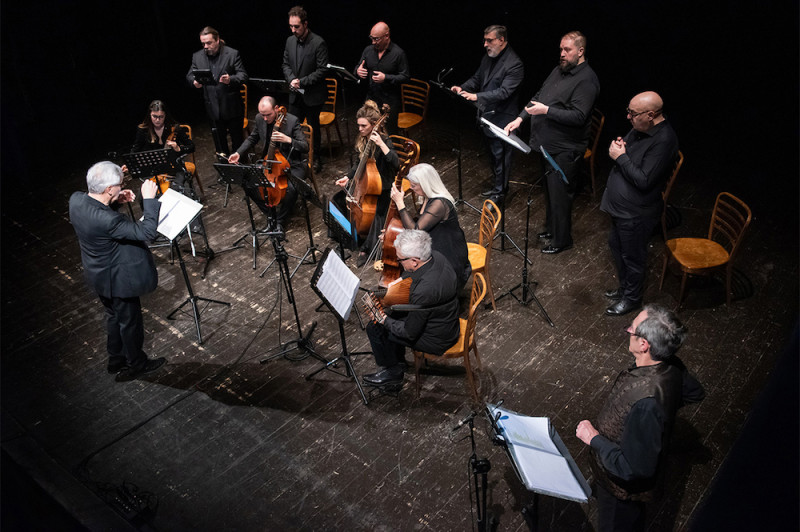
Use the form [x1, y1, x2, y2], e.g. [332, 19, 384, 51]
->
[283, 31, 328, 106]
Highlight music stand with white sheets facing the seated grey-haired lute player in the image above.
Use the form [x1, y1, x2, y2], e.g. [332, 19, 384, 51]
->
[306, 248, 369, 405]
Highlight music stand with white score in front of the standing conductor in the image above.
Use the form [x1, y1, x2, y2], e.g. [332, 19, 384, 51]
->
[158, 189, 231, 345]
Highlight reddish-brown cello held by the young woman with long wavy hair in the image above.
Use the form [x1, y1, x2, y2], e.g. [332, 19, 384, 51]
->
[347, 104, 389, 237]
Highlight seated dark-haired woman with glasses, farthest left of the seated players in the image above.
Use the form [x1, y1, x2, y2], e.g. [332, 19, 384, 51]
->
[131, 100, 194, 191]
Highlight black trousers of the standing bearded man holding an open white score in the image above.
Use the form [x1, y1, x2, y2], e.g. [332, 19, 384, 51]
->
[542, 152, 583, 248]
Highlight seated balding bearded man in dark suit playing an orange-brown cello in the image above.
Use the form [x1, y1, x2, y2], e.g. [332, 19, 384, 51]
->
[228, 96, 308, 232]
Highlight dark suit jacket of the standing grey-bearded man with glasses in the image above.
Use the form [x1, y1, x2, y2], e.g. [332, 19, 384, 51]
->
[461, 46, 525, 127]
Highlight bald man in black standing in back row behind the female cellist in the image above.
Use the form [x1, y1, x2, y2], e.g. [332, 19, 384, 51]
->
[355, 22, 411, 134]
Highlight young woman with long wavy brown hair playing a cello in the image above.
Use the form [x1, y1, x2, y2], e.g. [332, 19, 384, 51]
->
[336, 100, 400, 266]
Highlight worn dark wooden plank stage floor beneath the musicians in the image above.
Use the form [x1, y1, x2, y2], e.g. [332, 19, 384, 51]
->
[2, 111, 798, 530]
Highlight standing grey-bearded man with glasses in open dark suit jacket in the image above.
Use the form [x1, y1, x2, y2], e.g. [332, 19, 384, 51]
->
[450, 24, 525, 202]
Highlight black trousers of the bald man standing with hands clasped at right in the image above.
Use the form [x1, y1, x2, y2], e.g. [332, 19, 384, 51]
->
[608, 216, 659, 302]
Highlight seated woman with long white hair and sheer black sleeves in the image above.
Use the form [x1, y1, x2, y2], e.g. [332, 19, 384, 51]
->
[391, 163, 472, 289]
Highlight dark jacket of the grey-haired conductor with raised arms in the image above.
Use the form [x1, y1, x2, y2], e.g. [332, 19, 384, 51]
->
[69, 192, 161, 297]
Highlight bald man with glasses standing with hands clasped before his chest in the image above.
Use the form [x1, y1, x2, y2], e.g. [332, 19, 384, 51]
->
[600, 91, 678, 316]
